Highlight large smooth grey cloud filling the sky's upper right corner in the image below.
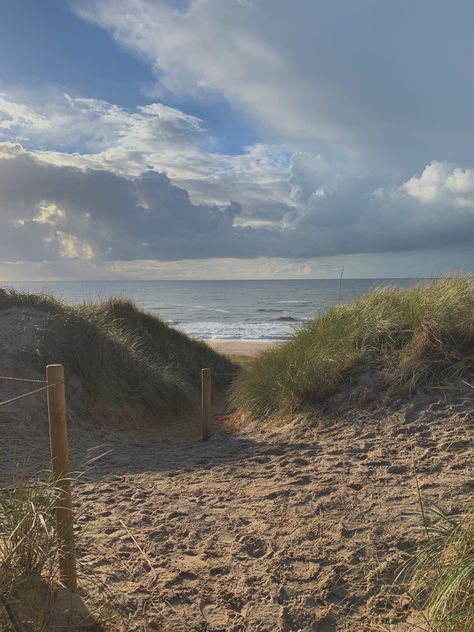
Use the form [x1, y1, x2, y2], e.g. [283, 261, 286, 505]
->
[72, 0, 474, 172]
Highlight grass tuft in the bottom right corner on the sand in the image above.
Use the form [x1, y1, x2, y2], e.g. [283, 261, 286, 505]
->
[401, 507, 474, 632]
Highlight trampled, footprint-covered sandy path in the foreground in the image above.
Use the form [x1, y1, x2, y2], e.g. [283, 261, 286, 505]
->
[64, 394, 473, 632]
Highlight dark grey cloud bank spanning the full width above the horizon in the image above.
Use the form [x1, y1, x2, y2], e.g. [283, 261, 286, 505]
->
[0, 144, 474, 261]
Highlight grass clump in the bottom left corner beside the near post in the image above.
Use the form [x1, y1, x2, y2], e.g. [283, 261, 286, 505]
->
[0, 472, 110, 632]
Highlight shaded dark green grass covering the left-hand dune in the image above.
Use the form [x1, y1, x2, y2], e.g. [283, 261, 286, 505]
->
[0, 288, 236, 419]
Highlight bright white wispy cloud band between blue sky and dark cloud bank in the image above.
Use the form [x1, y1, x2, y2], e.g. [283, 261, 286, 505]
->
[0, 94, 292, 219]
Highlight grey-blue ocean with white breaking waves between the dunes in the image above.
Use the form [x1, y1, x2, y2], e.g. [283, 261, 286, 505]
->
[2, 279, 417, 340]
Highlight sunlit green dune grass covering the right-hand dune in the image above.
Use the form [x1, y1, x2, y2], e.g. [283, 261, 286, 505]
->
[234, 274, 474, 417]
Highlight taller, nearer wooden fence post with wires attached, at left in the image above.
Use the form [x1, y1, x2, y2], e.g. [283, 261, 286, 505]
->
[46, 364, 77, 590]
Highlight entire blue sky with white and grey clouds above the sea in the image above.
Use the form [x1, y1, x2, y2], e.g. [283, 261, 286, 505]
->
[0, 0, 474, 281]
